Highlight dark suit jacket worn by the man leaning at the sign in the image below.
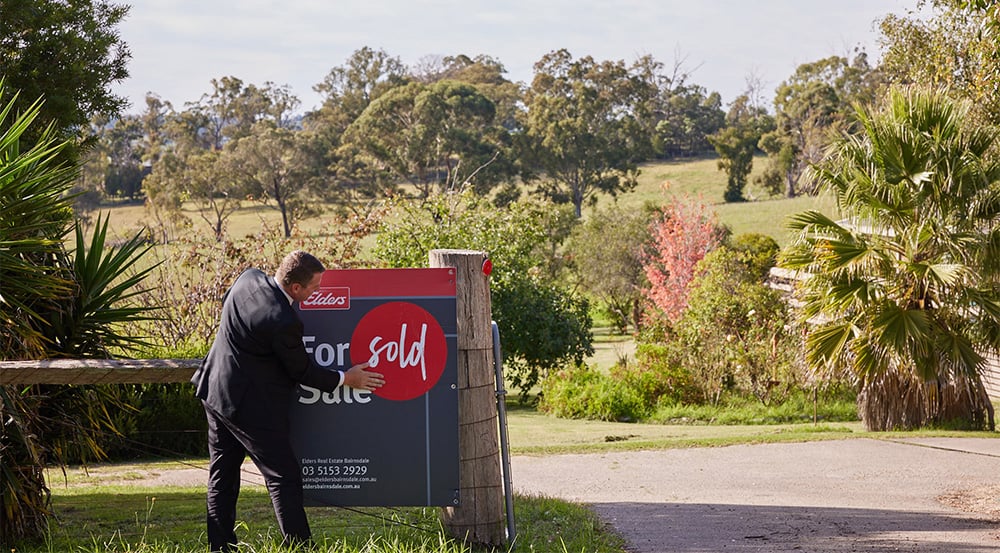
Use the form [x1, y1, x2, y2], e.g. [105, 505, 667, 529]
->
[191, 269, 342, 430]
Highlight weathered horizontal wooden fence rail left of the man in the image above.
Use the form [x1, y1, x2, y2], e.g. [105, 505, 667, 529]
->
[0, 359, 201, 385]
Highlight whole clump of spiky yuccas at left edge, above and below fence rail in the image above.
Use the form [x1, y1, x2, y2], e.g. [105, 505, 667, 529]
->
[0, 80, 160, 545]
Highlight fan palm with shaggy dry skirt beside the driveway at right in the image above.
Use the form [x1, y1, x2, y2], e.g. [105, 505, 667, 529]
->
[781, 89, 1000, 430]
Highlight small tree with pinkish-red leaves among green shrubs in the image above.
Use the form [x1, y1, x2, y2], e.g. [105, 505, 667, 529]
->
[642, 196, 723, 323]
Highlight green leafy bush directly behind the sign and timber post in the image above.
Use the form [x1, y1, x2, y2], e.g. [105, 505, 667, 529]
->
[374, 193, 593, 397]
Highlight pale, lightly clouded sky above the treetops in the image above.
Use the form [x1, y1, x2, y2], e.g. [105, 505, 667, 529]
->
[113, 0, 916, 113]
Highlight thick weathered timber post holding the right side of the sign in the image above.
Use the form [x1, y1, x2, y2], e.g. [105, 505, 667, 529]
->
[430, 250, 505, 545]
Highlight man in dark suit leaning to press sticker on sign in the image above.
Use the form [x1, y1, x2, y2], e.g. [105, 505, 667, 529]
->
[191, 251, 385, 552]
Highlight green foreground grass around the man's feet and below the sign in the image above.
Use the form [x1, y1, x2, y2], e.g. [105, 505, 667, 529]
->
[21, 486, 624, 553]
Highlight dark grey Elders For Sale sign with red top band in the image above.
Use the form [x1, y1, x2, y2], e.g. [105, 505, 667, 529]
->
[291, 268, 459, 506]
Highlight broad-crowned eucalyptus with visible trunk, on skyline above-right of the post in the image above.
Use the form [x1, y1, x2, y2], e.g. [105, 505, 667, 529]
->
[519, 49, 656, 217]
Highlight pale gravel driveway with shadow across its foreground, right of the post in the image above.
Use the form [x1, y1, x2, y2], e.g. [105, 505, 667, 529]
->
[511, 438, 1000, 553]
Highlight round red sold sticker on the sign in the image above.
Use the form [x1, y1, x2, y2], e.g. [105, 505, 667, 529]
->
[350, 301, 448, 401]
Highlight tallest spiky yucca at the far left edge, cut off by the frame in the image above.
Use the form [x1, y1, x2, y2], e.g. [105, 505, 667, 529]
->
[0, 81, 75, 544]
